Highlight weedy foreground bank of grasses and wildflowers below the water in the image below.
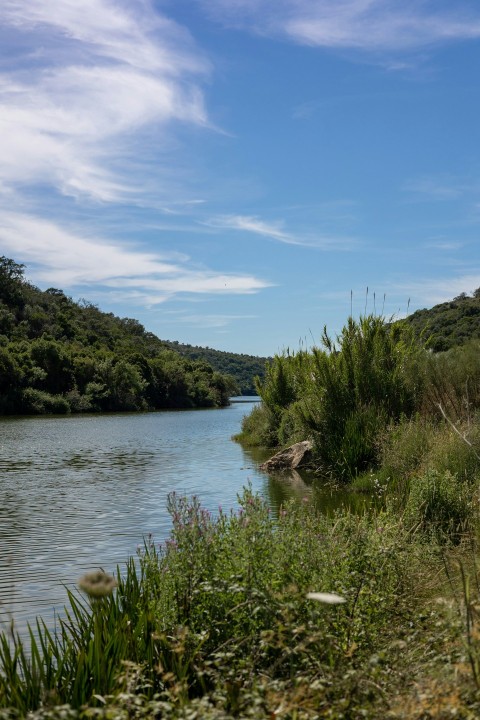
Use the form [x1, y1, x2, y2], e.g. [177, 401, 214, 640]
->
[0, 479, 480, 720]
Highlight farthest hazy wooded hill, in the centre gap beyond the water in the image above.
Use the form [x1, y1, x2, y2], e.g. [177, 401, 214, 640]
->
[165, 341, 271, 395]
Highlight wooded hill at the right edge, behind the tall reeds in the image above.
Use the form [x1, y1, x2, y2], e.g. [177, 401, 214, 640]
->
[406, 288, 480, 352]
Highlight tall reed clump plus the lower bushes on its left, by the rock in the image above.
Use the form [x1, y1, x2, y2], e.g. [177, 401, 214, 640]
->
[241, 315, 420, 479]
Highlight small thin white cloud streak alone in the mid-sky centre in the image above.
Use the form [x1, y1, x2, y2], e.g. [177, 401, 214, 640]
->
[202, 215, 356, 250]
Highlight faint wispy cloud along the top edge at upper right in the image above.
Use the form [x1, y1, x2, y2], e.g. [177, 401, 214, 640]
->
[200, 0, 480, 53]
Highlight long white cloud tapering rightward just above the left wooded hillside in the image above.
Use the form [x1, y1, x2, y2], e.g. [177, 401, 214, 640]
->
[0, 213, 270, 306]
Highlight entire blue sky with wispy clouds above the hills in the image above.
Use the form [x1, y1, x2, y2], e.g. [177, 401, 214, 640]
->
[0, 0, 480, 356]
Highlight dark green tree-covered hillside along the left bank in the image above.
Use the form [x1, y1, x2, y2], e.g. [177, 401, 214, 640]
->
[0, 256, 238, 414]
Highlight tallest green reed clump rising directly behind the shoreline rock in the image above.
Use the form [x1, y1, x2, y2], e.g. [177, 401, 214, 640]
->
[292, 315, 418, 480]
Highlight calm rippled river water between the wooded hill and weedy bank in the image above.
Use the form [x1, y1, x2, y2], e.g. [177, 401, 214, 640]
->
[0, 402, 360, 631]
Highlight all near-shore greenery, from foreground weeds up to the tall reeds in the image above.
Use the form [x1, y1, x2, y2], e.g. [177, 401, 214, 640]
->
[0, 278, 480, 720]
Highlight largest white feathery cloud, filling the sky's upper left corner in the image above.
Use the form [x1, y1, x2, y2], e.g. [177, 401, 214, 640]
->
[0, 0, 209, 202]
